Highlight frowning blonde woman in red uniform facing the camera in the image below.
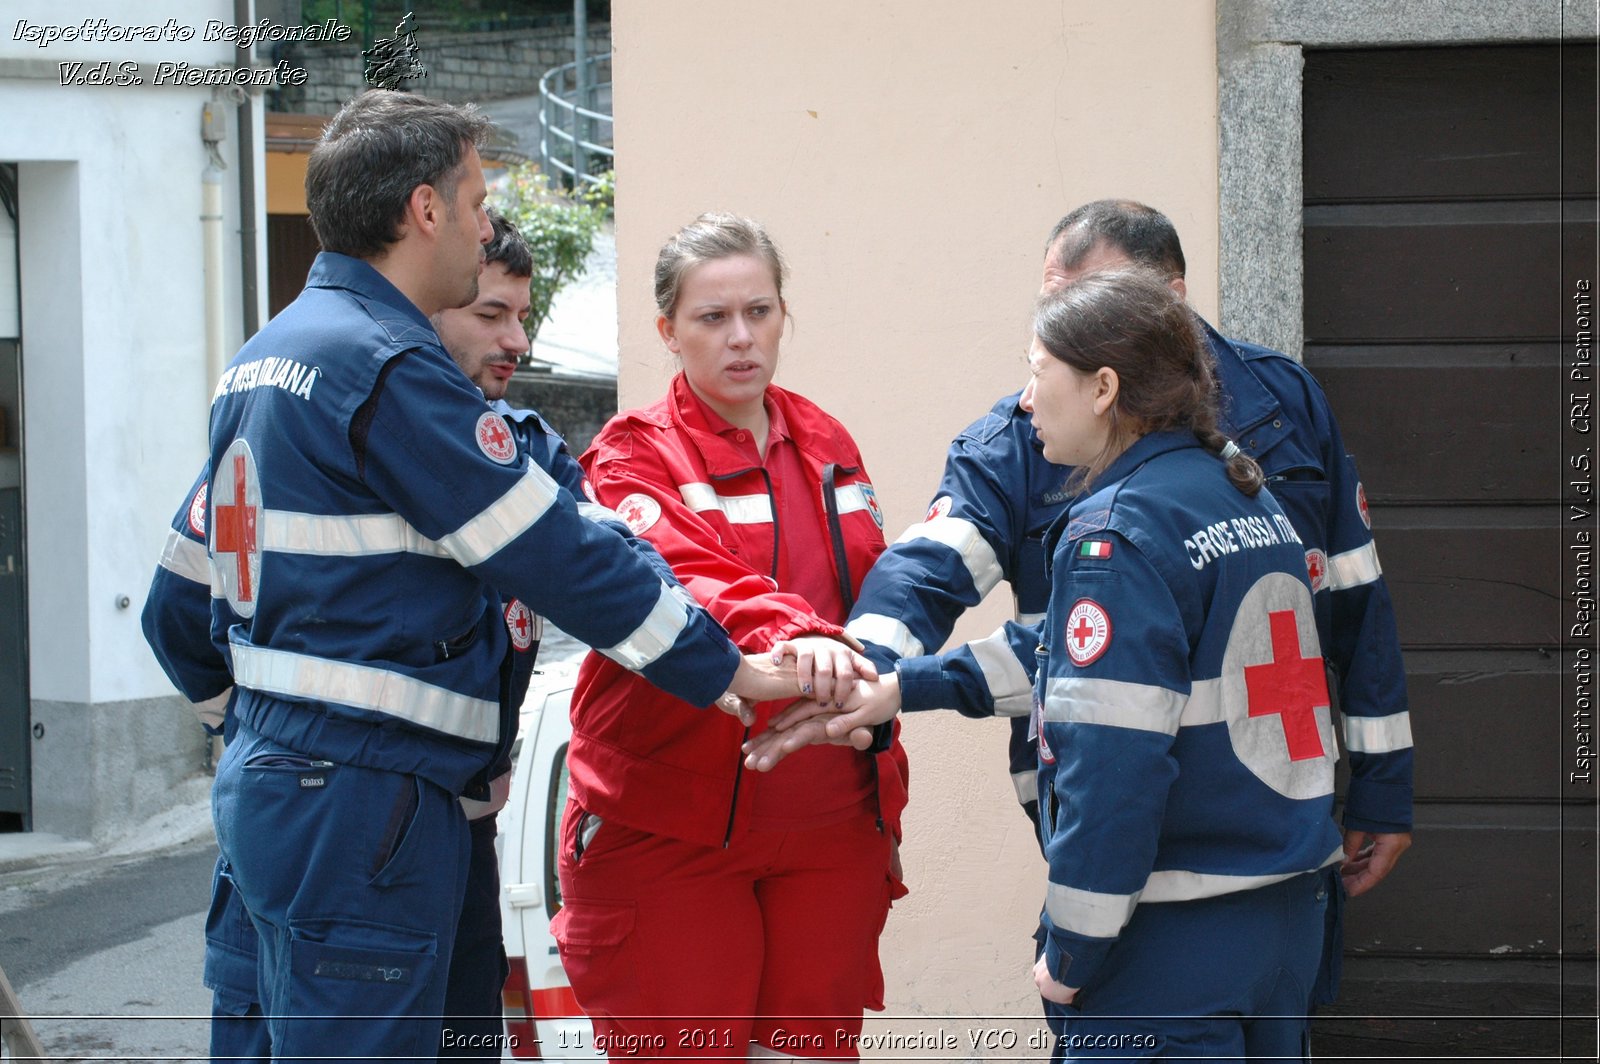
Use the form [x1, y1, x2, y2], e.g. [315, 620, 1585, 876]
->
[552, 214, 906, 1059]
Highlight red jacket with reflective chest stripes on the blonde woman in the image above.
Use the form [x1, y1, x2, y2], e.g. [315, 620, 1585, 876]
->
[566, 374, 907, 846]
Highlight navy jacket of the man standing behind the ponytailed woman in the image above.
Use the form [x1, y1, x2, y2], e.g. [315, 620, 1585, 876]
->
[848, 325, 1411, 832]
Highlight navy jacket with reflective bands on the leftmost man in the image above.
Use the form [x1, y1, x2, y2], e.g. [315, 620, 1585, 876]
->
[144, 253, 738, 794]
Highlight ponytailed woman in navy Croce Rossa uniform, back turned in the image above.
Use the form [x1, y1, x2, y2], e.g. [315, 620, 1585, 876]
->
[754, 270, 1341, 1059]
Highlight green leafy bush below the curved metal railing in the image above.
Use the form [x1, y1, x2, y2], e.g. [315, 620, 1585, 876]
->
[490, 163, 606, 342]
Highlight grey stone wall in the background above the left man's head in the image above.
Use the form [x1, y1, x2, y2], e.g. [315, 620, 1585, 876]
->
[267, 22, 611, 115]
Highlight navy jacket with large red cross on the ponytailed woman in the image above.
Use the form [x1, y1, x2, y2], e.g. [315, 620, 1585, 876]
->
[1035, 432, 1342, 987]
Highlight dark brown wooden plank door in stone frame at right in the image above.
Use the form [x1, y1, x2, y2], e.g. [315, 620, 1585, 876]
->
[1304, 43, 1597, 1056]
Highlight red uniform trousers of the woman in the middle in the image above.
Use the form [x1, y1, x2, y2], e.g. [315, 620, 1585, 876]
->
[552, 800, 890, 1061]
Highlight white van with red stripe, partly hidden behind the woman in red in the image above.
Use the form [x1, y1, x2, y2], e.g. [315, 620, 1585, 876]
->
[498, 659, 597, 1061]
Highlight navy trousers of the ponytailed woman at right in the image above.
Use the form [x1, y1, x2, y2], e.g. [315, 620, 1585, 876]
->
[1045, 867, 1339, 1061]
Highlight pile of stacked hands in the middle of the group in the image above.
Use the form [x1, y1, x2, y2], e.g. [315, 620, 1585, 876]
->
[717, 635, 901, 771]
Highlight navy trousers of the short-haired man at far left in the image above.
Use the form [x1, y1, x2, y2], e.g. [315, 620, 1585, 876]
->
[213, 725, 469, 1061]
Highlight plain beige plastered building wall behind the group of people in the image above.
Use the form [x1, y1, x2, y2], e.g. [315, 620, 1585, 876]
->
[613, 0, 1218, 1058]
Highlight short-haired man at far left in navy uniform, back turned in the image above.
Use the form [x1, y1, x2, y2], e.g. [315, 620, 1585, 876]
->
[147, 91, 800, 1059]
